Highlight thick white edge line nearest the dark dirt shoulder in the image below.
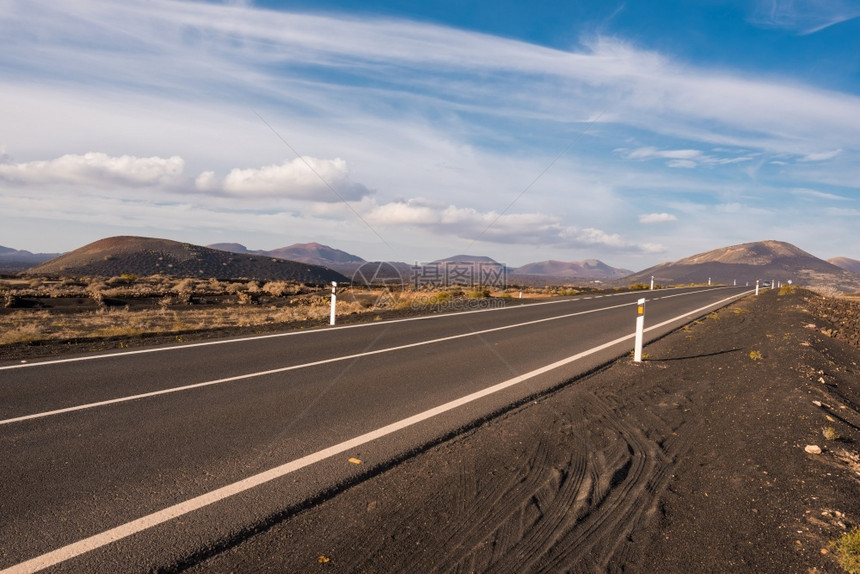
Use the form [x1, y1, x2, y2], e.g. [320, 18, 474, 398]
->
[0, 291, 750, 574]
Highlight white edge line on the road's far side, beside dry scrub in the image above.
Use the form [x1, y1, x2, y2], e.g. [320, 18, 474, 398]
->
[0, 287, 736, 371]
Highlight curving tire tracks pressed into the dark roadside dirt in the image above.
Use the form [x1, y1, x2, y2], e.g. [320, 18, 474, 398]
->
[428, 389, 687, 574]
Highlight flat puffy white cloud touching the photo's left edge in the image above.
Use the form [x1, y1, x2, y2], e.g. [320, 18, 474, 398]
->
[0, 152, 185, 187]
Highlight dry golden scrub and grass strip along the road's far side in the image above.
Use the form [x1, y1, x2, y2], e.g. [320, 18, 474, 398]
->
[0, 273, 600, 345]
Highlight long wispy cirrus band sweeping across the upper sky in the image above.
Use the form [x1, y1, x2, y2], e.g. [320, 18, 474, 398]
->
[2, 0, 860, 159]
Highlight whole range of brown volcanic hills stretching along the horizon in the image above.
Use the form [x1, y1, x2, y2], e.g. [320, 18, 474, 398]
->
[6, 236, 860, 292]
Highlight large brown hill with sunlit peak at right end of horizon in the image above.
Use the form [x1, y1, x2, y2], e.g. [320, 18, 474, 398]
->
[627, 240, 860, 291]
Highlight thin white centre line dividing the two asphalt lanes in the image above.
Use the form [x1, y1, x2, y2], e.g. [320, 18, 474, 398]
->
[0, 301, 636, 425]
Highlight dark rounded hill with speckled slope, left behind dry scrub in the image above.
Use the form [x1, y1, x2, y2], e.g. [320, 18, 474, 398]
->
[27, 236, 346, 284]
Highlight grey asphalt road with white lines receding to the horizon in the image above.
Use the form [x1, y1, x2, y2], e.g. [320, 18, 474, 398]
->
[0, 287, 749, 573]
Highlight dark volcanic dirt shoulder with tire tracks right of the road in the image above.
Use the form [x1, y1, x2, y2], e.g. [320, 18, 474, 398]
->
[178, 291, 860, 573]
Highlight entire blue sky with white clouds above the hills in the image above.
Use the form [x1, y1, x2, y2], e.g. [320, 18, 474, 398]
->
[0, 0, 860, 270]
